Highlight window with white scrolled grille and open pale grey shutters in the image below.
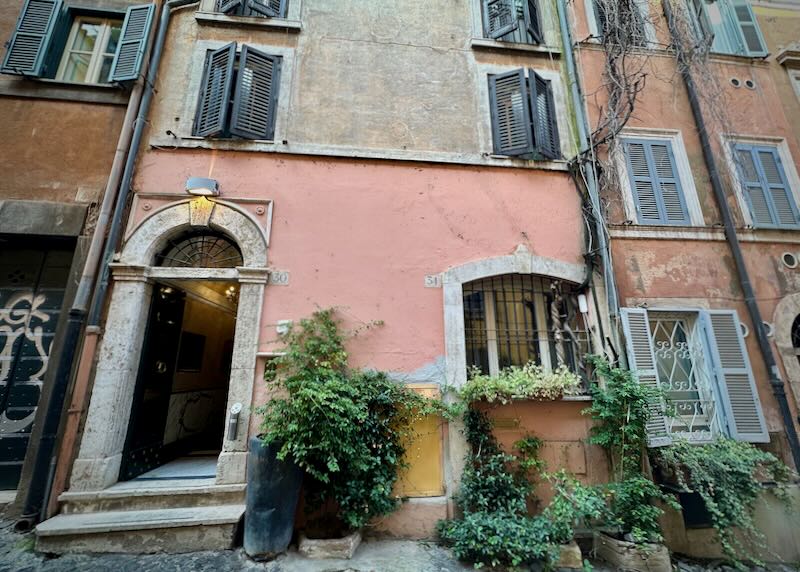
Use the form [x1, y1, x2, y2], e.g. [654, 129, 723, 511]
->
[621, 308, 769, 447]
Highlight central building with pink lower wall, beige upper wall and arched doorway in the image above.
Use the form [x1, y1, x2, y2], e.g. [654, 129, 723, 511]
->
[28, 0, 608, 552]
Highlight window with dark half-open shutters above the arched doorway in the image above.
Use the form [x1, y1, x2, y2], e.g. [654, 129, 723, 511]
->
[192, 42, 281, 140]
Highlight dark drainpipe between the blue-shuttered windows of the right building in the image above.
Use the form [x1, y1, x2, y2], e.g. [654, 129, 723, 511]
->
[663, 0, 800, 467]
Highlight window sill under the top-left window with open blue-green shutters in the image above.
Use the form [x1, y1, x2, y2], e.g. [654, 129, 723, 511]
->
[0, 75, 129, 105]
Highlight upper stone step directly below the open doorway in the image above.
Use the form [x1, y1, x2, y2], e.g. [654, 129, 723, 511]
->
[58, 479, 246, 514]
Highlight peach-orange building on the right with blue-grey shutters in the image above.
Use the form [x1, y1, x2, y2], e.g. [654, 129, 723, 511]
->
[574, 0, 800, 559]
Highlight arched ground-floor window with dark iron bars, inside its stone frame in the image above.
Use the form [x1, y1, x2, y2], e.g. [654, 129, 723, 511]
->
[463, 274, 589, 382]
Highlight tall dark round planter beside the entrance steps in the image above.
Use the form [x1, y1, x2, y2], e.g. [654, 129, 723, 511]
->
[244, 437, 303, 560]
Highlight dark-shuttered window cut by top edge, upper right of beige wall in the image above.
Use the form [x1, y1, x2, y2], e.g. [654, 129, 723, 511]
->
[481, 0, 544, 44]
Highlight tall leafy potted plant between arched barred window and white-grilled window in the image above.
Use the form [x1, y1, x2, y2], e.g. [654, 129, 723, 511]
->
[584, 356, 677, 572]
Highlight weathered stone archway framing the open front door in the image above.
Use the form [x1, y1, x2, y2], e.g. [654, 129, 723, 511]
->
[70, 197, 268, 491]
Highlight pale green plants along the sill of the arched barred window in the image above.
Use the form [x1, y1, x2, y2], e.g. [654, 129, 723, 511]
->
[461, 362, 581, 404]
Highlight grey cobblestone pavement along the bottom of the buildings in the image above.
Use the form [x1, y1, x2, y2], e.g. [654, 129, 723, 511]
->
[0, 521, 800, 572]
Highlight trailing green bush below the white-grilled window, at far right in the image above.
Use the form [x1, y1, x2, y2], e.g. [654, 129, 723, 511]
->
[655, 439, 792, 568]
